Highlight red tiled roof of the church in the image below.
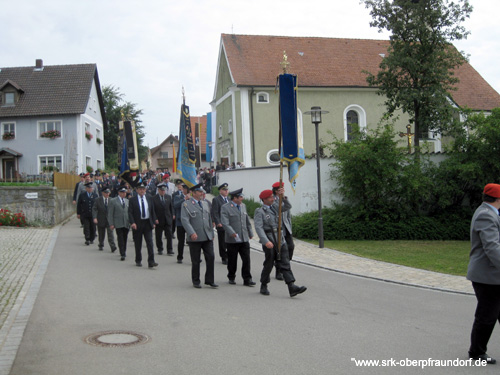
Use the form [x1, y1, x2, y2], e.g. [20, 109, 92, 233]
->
[222, 34, 500, 110]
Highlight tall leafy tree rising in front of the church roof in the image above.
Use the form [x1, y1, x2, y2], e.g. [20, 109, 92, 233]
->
[362, 0, 472, 151]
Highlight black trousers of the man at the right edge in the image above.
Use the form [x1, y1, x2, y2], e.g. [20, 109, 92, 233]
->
[469, 281, 500, 357]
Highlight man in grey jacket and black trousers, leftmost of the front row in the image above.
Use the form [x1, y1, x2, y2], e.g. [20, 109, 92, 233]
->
[179, 184, 218, 288]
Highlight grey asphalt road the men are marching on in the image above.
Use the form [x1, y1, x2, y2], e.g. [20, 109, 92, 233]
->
[7, 220, 500, 375]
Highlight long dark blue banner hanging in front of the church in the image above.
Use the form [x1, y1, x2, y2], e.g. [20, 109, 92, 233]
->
[278, 74, 305, 191]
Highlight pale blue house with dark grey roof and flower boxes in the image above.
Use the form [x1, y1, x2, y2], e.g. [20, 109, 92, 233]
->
[0, 59, 106, 179]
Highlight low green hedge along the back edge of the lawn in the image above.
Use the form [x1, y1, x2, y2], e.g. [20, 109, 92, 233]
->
[292, 208, 470, 241]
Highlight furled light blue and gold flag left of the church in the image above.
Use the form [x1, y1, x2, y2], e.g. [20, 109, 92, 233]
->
[177, 104, 196, 187]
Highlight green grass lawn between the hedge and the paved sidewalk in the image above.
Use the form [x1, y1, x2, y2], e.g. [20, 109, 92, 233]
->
[307, 240, 470, 276]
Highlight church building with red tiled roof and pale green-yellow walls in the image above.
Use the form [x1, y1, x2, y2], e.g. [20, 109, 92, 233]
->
[211, 34, 500, 167]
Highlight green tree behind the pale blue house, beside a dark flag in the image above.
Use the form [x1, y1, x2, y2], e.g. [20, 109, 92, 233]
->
[102, 85, 148, 169]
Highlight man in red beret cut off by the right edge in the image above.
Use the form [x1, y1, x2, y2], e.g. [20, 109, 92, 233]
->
[467, 184, 500, 364]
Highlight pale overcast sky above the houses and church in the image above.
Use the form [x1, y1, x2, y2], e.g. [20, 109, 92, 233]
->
[0, 0, 500, 147]
